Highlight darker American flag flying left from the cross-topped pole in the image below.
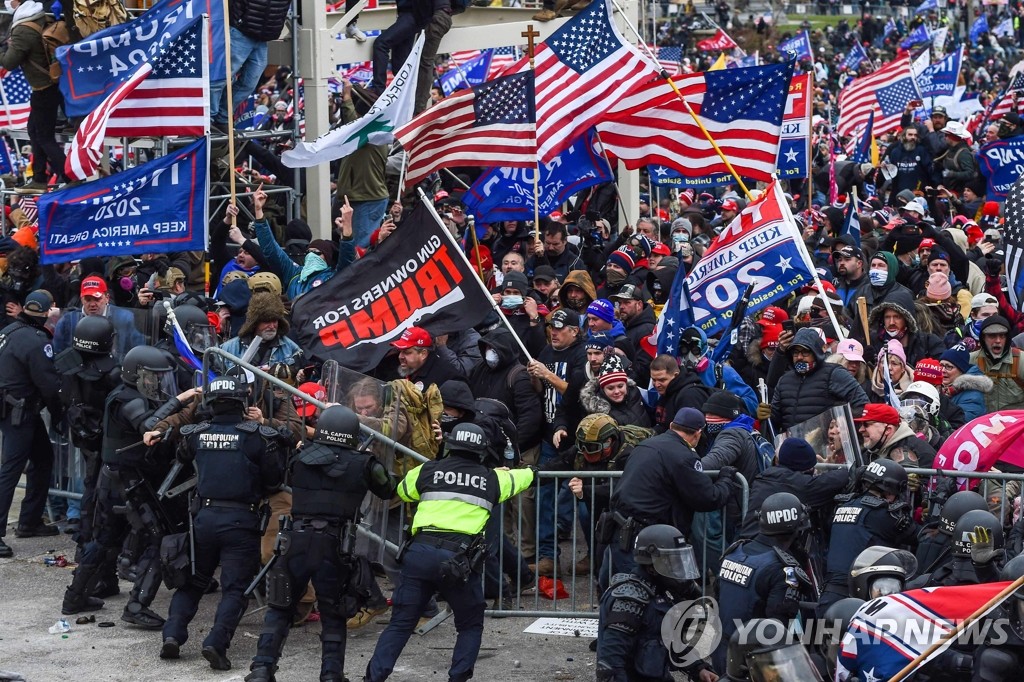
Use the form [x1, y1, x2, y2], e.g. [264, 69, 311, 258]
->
[394, 71, 537, 186]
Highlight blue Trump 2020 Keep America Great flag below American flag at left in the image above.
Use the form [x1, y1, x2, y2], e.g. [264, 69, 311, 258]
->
[39, 137, 209, 264]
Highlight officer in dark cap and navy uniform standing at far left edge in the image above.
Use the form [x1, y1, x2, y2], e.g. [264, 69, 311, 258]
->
[0, 289, 63, 558]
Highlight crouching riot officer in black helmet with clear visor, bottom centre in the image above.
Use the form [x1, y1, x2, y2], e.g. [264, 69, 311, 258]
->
[597, 523, 718, 682]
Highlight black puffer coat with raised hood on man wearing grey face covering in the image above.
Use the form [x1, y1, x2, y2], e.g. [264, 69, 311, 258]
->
[771, 328, 867, 432]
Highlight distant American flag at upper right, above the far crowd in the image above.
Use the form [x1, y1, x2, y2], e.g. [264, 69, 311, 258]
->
[838, 54, 918, 136]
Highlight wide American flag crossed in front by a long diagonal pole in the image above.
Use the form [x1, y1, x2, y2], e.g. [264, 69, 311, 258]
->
[597, 63, 793, 181]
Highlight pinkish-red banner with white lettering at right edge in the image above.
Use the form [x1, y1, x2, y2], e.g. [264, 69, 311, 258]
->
[935, 410, 1024, 487]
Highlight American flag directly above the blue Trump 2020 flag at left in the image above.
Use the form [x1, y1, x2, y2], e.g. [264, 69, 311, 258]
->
[106, 18, 210, 137]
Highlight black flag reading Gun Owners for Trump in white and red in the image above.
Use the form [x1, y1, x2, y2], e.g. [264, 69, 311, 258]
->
[292, 203, 493, 372]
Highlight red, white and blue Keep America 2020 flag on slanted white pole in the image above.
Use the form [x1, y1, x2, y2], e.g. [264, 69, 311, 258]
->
[686, 176, 813, 336]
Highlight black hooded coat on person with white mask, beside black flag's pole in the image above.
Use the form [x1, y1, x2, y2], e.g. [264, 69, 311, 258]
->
[469, 327, 544, 451]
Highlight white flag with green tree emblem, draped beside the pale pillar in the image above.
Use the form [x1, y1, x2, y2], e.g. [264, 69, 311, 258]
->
[281, 33, 424, 168]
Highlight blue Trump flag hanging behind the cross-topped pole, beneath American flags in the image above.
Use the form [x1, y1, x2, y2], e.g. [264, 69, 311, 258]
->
[463, 129, 612, 222]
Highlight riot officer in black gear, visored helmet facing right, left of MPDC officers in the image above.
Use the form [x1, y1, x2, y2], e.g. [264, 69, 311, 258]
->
[61, 346, 196, 630]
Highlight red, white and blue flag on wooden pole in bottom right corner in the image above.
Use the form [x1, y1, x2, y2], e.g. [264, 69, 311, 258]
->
[836, 583, 1011, 682]
